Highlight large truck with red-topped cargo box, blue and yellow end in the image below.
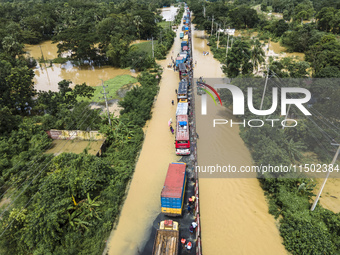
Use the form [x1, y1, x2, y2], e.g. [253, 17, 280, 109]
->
[161, 162, 187, 216]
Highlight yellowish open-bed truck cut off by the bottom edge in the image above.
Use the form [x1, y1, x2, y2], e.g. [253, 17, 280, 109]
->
[152, 220, 179, 255]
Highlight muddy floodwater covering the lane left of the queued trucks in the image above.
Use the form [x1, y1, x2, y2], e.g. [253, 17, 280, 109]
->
[104, 27, 180, 255]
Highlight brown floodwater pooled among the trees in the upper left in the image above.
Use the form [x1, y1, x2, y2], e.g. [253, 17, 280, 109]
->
[25, 41, 136, 91]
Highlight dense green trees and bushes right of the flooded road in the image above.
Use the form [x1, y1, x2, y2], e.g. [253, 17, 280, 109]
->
[189, 0, 340, 254]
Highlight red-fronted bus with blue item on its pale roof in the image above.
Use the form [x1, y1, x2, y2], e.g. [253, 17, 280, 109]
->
[175, 115, 190, 155]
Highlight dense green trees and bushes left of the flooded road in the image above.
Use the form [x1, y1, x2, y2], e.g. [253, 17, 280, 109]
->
[0, 0, 183, 255]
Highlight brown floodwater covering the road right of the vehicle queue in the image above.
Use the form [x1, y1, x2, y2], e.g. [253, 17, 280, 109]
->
[193, 31, 287, 255]
